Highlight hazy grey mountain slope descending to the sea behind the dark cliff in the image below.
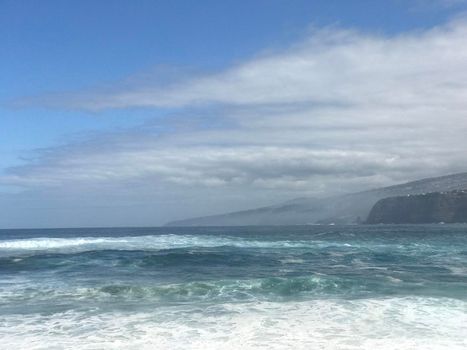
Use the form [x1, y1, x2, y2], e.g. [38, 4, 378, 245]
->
[167, 172, 467, 226]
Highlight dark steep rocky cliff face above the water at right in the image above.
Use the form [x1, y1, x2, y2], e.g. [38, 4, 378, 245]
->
[367, 190, 467, 224]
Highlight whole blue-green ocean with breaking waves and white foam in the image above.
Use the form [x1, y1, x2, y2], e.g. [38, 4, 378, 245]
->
[0, 225, 467, 350]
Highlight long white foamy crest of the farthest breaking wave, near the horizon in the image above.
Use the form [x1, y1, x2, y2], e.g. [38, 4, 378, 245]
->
[0, 234, 460, 256]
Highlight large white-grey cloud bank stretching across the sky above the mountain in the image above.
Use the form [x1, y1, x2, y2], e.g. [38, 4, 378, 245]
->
[0, 19, 467, 224]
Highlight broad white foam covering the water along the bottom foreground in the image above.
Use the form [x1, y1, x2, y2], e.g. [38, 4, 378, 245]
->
[0, 297, 467, 350]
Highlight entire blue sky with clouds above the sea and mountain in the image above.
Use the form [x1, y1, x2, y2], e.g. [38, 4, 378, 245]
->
[0, 0, 467, 228]
